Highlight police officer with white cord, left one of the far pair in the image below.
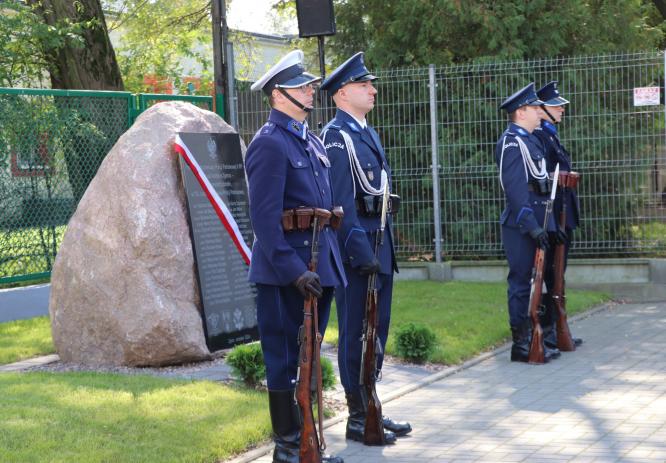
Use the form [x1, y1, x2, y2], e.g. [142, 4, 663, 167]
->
[495, 83, 560, 362]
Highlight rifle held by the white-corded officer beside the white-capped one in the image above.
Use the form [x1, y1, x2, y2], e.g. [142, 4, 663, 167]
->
[359, 171, 390, 445]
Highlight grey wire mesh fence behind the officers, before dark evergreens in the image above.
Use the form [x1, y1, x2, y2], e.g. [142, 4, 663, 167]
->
[233, 52, 666, 260]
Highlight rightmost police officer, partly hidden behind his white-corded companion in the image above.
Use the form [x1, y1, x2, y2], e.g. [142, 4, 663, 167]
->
[534, 80, 583, 348]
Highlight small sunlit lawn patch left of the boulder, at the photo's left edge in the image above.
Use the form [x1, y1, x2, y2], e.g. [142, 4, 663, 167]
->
[0, 316, 55, 365]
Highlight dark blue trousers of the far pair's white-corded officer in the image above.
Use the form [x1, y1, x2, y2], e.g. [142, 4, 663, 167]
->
[502, 225, 536, 326]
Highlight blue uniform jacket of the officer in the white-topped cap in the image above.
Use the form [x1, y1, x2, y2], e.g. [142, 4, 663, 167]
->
[245, 109, 347, 286]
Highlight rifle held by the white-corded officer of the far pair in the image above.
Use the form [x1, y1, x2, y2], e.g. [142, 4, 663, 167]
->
[527, 164, 560, 363]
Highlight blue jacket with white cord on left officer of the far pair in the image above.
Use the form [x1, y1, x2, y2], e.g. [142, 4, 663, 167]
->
[495, 123, 555, 234]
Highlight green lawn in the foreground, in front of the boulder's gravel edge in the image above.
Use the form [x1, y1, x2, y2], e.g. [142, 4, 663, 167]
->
[0, 373, 270, 463]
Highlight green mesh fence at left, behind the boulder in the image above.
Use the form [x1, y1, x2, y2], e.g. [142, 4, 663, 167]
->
[0, 89, 212, 283]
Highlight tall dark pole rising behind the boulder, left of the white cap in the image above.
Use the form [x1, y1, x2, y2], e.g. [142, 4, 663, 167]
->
[211, 0, 229, 118]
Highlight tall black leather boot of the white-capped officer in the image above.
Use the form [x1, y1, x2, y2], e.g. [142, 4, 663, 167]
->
[268, 389, 301, 463]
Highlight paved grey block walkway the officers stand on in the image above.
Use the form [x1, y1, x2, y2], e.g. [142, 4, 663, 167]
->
[234, 303, 666, 463]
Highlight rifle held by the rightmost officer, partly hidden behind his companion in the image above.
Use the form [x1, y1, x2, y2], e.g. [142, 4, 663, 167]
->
[552, 172, 579, 352]
